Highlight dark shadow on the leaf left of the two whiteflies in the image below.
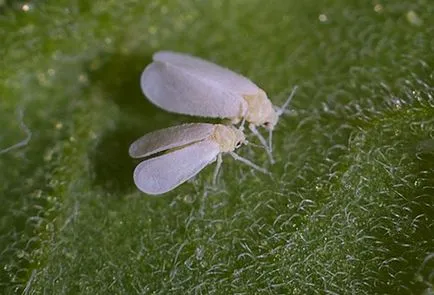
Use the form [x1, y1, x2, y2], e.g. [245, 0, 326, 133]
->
[88, 54, 162, 194]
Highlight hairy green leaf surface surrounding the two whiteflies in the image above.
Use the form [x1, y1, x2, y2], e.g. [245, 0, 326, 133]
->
[0, 0, 434, 294]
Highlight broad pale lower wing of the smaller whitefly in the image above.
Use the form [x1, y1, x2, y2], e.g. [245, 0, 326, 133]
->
[134, 140, 220, 195]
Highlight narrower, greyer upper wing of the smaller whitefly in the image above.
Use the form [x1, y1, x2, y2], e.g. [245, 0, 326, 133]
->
[129, 123, 215, 158]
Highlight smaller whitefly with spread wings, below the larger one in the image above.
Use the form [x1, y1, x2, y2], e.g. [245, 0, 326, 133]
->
[129, 123, 269, 195]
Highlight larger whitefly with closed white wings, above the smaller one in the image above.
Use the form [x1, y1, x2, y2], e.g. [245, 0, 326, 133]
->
[141, 51, 297, 163]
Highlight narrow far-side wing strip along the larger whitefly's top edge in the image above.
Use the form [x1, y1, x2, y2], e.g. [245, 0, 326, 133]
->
[153, 51, 258, 95]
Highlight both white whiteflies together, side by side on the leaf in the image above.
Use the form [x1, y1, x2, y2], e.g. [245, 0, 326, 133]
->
[129, 51, 297, 195]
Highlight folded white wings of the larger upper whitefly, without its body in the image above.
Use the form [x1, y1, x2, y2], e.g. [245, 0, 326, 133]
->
[141, 52, 254, 118]
